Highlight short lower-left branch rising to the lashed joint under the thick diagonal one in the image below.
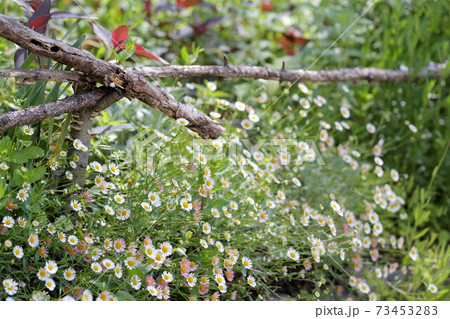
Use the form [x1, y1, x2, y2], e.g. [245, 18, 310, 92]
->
[0, 87, 118, 134]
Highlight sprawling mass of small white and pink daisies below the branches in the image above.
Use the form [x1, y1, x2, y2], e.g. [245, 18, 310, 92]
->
[0, 78, 438, 301]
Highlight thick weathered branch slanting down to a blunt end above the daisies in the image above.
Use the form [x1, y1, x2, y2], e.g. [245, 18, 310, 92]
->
[0, 14, 224, 138]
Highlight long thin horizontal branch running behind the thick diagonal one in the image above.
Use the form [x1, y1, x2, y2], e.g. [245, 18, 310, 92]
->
[0, 64, 446, 83]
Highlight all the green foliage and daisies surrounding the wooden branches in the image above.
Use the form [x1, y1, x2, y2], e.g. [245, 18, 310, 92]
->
[0, 0, 450, 300]
